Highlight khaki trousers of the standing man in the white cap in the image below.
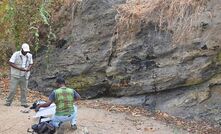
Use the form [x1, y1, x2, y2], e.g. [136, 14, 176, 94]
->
[6, 76, 28, 105]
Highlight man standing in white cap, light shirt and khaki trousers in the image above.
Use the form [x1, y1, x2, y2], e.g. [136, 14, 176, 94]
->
[5, 43, 33, 108]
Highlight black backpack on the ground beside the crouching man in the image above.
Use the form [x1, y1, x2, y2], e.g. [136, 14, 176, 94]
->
[29, 117, 56, 134]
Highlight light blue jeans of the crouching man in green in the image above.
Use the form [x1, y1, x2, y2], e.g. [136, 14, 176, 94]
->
[51, 106, 77, 128]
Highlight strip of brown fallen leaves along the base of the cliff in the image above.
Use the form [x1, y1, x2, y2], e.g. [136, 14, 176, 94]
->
[78, 100, 221, 134]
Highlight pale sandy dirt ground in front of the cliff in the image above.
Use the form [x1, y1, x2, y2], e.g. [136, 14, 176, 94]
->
[0, 100, 186, 134]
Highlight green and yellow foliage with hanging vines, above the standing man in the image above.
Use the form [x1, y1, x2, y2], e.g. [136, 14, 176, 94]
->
[0, 0, 58, 66]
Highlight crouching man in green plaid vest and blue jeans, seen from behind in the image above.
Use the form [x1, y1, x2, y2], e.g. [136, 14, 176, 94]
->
[36, 77, 81, 130]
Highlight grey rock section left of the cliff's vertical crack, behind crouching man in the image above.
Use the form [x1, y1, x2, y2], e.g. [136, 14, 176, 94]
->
[30, 0, 124, 97]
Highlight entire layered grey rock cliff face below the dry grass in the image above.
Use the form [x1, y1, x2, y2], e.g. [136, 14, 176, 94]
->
[30, 0, 221, 124]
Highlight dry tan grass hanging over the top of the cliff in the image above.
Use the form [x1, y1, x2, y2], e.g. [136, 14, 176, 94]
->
[116, 0, 208, 43]
